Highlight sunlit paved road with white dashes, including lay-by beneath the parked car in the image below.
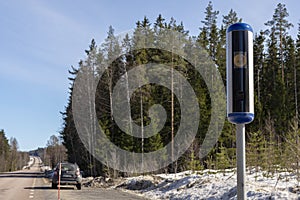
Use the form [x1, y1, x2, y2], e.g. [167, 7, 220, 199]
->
[0, 157, 149, 200]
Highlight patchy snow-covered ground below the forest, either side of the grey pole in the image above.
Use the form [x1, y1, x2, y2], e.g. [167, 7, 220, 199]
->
[117, 169, 300, 200]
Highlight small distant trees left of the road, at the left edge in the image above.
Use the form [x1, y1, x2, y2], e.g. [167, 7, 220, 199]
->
[0, 130, 29, 172]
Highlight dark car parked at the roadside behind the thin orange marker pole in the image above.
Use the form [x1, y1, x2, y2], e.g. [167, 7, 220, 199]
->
[52, 162, 82, 190]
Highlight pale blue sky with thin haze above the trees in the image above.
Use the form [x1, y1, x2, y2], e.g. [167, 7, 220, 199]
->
[0, 0, 300, 151]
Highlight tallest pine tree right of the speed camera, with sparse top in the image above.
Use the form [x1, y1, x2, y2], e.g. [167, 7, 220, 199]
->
[263, 3, 293, 139]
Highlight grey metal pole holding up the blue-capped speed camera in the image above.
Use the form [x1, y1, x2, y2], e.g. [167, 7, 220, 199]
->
[236, 124, 246, 200]
